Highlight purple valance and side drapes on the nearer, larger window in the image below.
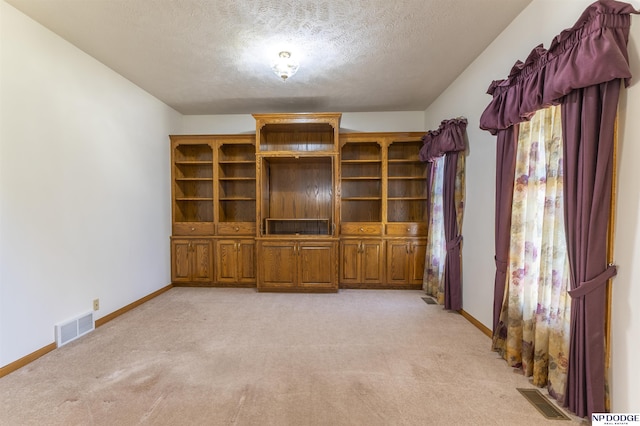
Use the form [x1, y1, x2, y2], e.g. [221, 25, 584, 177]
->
[480, 0, 640, 417]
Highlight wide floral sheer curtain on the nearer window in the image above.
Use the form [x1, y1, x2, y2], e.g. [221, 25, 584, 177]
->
[493, 107, 571, 400]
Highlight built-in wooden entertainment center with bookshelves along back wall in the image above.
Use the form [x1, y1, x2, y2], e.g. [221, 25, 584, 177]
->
[171, 113, 427, 292]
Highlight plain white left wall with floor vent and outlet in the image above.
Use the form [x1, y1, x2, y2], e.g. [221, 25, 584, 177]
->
[0, 0, 181, 366]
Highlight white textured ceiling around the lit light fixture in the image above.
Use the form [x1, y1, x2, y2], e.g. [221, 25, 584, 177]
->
[6, 0, 531, 114]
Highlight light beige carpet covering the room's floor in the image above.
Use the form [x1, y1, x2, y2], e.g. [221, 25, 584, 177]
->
[0, 288, 580, 426]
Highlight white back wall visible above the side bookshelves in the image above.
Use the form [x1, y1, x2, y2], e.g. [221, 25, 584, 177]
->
[180, 111, 425, 134]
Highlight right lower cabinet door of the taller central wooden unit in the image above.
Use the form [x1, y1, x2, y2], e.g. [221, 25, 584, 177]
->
[297, 242, 338, 288]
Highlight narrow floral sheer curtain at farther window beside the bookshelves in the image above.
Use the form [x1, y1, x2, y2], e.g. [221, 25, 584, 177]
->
[422, 157, 447, 305]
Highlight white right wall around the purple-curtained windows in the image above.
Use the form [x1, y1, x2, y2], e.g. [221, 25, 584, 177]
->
[425, 0, 640, 412]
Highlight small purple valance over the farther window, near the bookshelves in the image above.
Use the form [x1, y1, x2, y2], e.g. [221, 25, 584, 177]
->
[420, 118, 467, 161]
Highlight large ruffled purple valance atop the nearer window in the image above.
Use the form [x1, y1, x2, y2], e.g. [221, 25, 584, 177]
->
[480, 0, 638, 135]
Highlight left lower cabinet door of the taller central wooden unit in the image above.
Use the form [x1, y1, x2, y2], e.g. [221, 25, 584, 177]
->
[258, 241, 298, 289]
